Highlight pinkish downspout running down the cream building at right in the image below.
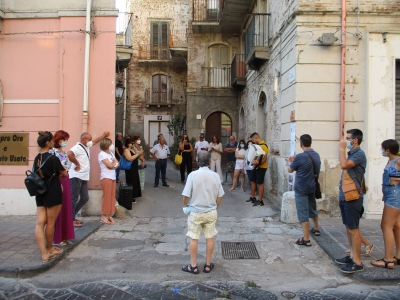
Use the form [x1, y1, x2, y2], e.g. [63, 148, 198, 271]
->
[340, 0, 346, 138]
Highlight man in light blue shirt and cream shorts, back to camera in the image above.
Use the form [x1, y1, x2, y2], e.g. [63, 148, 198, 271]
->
[182, 151, 224, 274]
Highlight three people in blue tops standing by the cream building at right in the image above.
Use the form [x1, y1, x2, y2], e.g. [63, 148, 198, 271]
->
[288, 129, 400, 274]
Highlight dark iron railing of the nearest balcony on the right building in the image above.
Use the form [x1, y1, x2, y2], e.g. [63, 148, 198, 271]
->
[245, 15, 269, 59]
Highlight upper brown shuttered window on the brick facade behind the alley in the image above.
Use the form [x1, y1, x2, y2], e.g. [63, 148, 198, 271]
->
[150, 22, 170, 59]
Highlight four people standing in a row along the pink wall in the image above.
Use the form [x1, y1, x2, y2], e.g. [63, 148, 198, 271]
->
[33, 130, 110, 262]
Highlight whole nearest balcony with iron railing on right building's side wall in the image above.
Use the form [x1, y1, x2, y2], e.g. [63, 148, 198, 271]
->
[245, 14, 269, 70]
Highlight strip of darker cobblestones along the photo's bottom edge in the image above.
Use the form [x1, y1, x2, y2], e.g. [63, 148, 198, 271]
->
[0, 278, 400, 300]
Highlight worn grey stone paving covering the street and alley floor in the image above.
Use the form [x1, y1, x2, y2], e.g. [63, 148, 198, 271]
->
[0, 163, 400, 300]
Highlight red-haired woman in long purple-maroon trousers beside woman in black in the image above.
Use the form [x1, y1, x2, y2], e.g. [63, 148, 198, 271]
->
[49, 130, 75, 246]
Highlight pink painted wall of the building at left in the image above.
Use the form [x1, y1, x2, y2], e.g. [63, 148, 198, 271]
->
[0, 17, 116, 193]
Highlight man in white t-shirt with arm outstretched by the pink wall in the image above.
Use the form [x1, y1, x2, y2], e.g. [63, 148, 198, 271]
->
[67, 131, 110, 227]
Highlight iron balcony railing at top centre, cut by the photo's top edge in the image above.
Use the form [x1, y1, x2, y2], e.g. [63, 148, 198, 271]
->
[193, 0, 223, 22]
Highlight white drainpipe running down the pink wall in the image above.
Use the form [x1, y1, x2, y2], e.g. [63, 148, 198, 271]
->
[82, 0, 92, 132]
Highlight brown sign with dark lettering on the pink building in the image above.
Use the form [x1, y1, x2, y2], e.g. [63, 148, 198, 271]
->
[0, 132, 29, 165]
